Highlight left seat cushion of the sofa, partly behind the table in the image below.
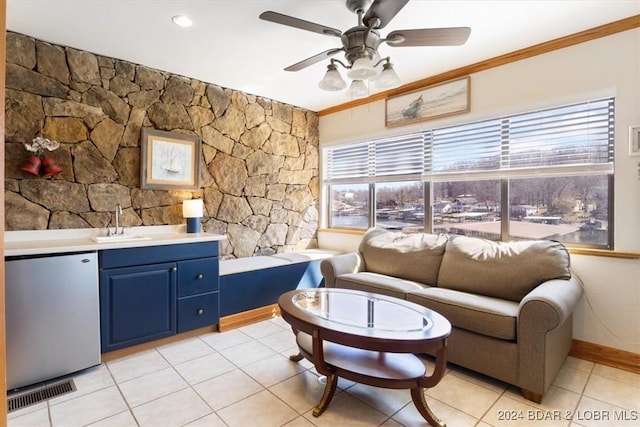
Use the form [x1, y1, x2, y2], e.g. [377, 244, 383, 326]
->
[336, 272, 424, 299]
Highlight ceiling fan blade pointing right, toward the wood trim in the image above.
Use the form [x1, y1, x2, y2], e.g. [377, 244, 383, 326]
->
[385, 27, 471, 47]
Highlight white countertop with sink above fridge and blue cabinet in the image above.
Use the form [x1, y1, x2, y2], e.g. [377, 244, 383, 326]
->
[4, 225, 226, 257]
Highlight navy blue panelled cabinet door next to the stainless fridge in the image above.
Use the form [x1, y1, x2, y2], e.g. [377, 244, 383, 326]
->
[100, 263, 177, 353]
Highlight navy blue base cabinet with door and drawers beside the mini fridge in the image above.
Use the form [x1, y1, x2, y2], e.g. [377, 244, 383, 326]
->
[99, 241, 219, 353]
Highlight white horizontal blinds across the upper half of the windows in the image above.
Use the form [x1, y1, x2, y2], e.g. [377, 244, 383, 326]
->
[325, 98, 614, 184]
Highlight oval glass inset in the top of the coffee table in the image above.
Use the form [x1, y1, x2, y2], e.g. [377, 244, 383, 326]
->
[292, 288, 432, 332]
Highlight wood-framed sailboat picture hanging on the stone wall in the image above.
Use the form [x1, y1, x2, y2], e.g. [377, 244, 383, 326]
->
[140, 128, 202, 190]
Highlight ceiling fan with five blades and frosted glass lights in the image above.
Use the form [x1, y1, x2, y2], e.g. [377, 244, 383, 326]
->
[260, 0, 471, 97]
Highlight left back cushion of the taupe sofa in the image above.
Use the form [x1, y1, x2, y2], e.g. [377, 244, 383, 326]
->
[360, 228, 447, 286]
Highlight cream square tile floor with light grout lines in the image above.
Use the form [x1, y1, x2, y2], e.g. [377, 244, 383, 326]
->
[8, 318, 640, 427]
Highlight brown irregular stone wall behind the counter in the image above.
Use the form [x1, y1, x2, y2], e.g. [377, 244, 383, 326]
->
[5, 32, 318, 257]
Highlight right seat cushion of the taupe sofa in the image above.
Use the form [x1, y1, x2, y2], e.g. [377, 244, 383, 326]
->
[407, 288, 518, 341]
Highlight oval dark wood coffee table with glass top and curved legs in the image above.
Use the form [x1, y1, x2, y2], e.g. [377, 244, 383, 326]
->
[278, 288, 451, 426]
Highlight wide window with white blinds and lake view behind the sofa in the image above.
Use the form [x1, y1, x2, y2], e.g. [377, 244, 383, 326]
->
[323, 98, 614, 248]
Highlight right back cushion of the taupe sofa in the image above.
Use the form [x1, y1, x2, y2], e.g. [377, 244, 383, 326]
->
[438, 236, 571, 302]
